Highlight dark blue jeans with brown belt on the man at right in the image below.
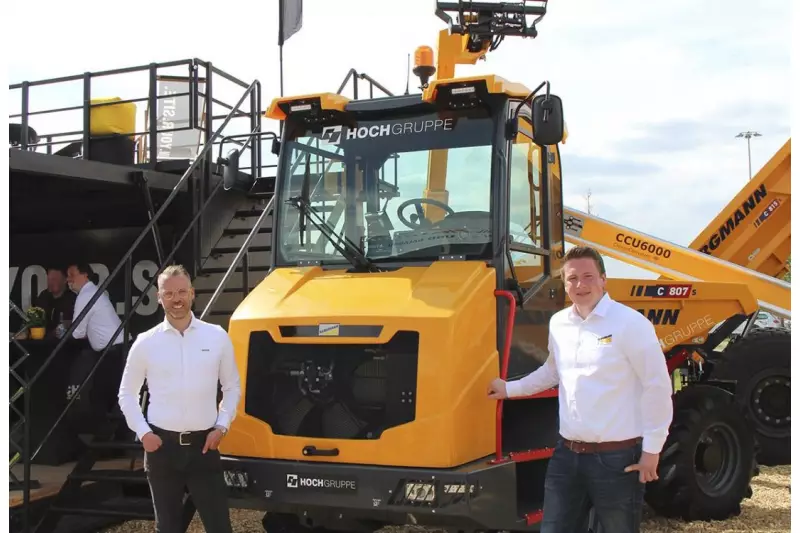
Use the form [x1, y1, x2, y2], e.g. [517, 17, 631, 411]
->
[541, 440, 645, 533]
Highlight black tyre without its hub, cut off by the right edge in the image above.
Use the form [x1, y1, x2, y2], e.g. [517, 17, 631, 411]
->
[711, 328, 792, 466]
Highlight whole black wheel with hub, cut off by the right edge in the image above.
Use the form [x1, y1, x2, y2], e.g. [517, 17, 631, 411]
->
[711, 328, 792, 466]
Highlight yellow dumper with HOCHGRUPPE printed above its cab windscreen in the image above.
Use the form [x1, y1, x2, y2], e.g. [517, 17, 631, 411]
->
[221, 1, 757, 533]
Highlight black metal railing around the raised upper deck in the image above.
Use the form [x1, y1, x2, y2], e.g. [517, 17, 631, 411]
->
[9, 59, 262, 181]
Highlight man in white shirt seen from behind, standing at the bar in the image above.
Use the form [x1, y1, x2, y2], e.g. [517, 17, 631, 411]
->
[67, 263, 125, 429]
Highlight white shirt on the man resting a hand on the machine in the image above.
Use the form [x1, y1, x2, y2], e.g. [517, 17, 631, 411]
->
[506, 294, 672, 453]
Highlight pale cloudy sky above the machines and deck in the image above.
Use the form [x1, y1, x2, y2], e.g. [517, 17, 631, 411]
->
[7, 0, 792, 277]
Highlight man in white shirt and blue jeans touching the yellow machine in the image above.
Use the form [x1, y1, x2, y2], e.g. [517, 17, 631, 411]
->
[489, 247, 672, 533]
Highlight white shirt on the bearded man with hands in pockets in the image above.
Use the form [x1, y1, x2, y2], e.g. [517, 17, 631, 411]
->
[119, 315, 241, 439]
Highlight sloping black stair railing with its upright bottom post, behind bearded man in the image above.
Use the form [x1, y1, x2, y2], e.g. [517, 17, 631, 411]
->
[11, 76, 260, 532]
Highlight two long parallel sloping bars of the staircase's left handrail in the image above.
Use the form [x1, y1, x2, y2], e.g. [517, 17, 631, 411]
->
[19, 81, 258, 486]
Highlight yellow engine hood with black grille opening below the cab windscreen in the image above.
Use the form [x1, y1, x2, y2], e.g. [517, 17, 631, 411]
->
[222, 261, 499, 467]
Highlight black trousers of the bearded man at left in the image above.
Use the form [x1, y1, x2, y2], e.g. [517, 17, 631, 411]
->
[144, 428, 231, 533]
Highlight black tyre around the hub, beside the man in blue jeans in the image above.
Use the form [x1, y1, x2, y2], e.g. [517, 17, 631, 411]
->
[645, 385, 758, 521]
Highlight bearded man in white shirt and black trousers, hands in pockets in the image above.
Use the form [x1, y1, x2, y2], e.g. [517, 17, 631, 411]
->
[119, 265, 241, 533]
